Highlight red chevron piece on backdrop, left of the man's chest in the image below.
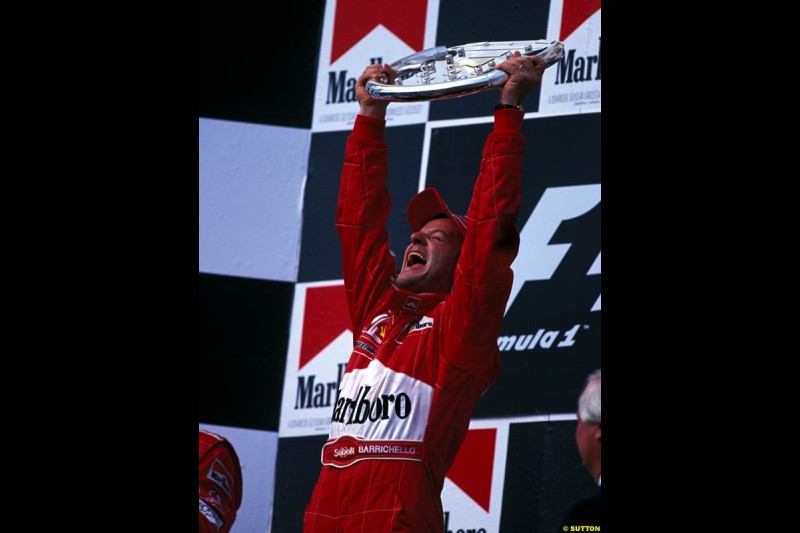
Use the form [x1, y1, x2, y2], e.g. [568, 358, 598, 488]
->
[298, 284, 351, 370]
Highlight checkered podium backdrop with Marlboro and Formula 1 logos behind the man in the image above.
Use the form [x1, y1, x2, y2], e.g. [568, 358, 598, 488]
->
[199, 0, 602, 533]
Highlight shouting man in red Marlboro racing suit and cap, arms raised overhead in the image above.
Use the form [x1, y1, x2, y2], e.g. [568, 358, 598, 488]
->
[303, 53, 545, 533]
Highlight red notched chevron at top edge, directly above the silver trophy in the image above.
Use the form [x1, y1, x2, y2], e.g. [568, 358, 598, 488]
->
[331, 0, 428, 64]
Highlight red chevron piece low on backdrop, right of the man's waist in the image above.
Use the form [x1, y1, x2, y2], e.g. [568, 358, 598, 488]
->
[445, 428, 497, 513]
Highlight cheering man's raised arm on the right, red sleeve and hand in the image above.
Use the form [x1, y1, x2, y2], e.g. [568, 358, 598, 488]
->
[444, 52, 546, 369]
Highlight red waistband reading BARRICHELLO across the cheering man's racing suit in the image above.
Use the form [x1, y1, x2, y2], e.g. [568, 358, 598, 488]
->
[322, 435, 424, 468]
